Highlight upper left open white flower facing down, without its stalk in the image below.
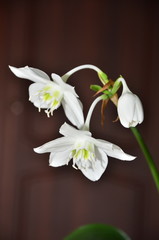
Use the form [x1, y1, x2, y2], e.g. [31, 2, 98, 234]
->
[9, 66, 84, 128]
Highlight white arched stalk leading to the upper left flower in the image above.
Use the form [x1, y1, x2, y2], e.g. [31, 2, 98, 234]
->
[62, 64, 102, 82]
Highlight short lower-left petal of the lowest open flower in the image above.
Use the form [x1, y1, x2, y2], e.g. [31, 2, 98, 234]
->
[49, 148, 71, 167]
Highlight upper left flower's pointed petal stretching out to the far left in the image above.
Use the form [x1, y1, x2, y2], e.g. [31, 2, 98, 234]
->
[9, 66, 50, 83]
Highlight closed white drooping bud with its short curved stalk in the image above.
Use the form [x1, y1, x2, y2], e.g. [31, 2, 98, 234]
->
[117, 77, 144, 128]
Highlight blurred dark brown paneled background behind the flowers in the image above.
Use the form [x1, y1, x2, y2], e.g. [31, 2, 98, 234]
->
[0, 0, 159, 240]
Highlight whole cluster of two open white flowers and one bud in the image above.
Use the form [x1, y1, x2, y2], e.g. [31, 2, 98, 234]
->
[10, 65, 144, 181]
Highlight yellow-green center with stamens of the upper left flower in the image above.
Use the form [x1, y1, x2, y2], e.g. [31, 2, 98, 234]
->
[38, 85, 63, 117]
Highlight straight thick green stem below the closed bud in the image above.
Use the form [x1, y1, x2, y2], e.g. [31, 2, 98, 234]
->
[131, 127, 159, 191]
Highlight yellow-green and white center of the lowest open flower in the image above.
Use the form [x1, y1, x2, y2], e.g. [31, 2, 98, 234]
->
[70, 141, 95, 169]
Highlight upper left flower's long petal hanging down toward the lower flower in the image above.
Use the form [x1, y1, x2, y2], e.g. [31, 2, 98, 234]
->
[62, 92, 84, 129]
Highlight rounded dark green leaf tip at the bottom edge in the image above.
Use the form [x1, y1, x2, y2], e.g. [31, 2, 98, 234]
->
[64, 224, 130, 240]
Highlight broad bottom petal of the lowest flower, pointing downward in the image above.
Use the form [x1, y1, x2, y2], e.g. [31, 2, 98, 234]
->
[80, 148, 108, 181]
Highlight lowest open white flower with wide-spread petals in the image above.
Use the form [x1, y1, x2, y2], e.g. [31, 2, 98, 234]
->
[34, 123, 135, 181]
